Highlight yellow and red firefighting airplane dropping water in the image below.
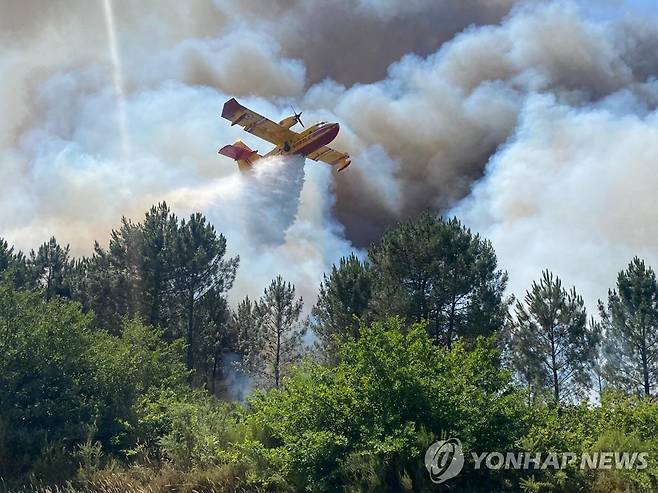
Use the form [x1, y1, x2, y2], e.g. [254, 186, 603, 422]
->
[219, 98, 351, 171]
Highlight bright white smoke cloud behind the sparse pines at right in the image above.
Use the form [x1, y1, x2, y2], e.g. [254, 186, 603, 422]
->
[453, 87, 658, 307]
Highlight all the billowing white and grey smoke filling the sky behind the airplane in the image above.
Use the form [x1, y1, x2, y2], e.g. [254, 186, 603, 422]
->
[0, 0, 658, 308]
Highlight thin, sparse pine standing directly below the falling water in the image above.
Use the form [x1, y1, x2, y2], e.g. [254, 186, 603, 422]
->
[242, 276, 307, 388]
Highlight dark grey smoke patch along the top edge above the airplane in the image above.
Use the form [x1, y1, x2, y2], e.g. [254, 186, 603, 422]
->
[217, 0, 516, 85]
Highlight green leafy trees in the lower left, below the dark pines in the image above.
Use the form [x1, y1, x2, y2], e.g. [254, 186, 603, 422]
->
[0, 283, 186, 482]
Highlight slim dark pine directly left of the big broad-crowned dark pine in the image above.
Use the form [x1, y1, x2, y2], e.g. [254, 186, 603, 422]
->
[313, 254, 372, 350]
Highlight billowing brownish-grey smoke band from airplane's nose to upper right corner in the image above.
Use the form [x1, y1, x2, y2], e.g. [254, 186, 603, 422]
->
[316, 2, 658, 243]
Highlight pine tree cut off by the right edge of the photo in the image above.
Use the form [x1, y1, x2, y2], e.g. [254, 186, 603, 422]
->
[599, 257, 658, 396]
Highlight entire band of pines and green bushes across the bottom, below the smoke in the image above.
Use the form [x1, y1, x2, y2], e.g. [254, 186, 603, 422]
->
[0, 203, 658, 492]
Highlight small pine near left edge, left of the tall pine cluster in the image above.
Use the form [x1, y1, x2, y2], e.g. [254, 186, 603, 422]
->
[27, 237, 73, 301]
